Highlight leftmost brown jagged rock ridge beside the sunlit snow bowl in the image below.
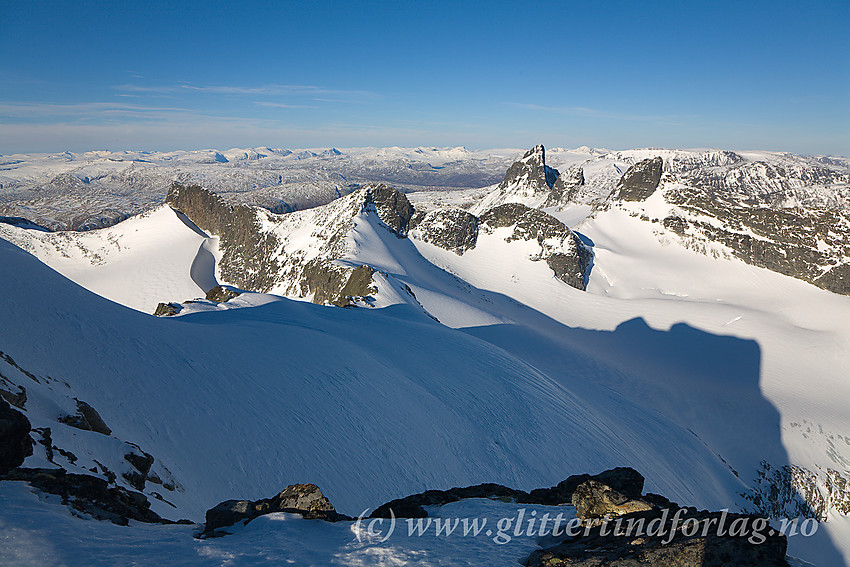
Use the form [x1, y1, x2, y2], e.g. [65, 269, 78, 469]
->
[165, 183, 280, 292]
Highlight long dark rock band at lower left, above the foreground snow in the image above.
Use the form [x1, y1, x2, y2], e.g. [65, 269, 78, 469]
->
[3, 469, 174, 526]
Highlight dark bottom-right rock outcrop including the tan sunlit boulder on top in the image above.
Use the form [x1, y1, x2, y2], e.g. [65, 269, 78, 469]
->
[525, 469, 788, 567]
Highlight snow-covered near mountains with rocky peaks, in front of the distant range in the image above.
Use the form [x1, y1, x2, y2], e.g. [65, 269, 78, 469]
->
[0, 146, 850, 565]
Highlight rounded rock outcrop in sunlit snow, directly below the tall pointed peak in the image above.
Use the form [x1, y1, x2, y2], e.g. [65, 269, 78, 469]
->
[480, 203, 593, 290]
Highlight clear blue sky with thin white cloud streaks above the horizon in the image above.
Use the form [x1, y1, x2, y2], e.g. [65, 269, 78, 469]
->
[0, 0, 850, 155]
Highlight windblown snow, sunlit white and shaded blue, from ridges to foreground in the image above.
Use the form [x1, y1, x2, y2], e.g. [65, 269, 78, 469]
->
[0, 154, 850, 565]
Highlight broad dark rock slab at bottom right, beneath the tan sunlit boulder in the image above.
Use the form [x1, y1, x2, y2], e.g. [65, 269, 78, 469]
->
[525, 505, 788, 567]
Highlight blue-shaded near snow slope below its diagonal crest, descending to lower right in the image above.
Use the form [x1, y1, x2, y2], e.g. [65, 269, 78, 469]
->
[0, 235, 740, 519]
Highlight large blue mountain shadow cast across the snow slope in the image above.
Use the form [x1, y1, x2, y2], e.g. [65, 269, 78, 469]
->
[0, 234, 841, 564]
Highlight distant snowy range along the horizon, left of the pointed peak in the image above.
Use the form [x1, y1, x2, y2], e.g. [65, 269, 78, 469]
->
[0, 148, 519, 230]
